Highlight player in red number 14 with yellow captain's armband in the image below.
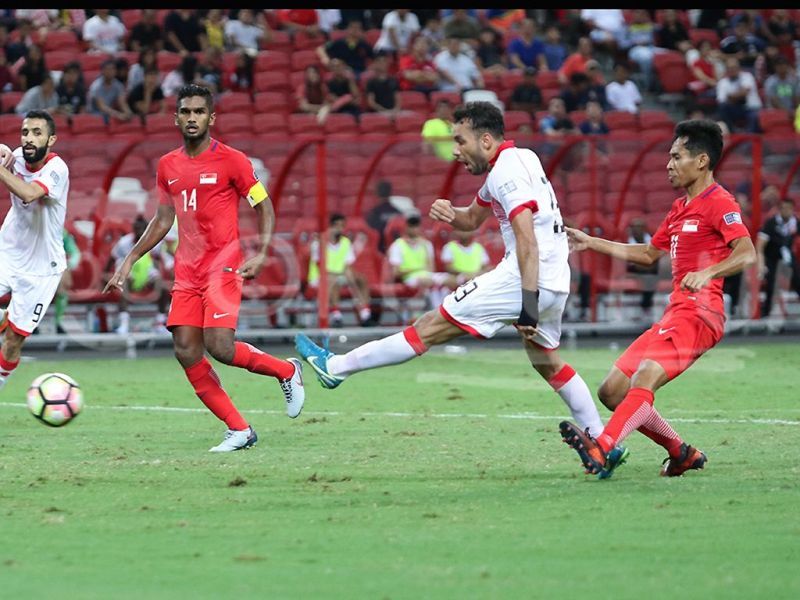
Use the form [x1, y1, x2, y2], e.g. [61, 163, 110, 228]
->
[104, 84, 305, 452]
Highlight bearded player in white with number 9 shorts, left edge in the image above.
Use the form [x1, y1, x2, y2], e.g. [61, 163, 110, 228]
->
[0, 110, 69, 388]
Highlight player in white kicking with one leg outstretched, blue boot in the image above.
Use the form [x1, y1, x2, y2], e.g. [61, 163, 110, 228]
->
[295, 102, 628, 478]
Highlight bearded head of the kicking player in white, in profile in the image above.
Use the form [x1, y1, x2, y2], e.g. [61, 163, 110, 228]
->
[453, 102, 505, 175]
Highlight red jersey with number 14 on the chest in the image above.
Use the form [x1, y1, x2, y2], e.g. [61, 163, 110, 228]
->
[156, 139, 261, 287]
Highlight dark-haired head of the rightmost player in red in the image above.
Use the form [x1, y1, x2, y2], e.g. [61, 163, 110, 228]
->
[667, 119, 723, 188]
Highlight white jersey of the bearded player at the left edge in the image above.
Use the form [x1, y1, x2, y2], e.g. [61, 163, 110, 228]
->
[0, 147, 69, 276]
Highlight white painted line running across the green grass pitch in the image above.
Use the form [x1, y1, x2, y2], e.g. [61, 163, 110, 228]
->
[0, 402, 800, 425]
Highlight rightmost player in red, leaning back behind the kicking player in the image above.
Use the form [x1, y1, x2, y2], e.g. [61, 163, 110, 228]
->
[560, 120, 756, 477]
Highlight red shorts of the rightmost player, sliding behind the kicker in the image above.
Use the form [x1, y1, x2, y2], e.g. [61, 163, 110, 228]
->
[614, 303, 725, 379]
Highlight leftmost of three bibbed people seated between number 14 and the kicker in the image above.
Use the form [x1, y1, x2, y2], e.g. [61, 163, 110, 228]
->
[308, 213, 374, 327]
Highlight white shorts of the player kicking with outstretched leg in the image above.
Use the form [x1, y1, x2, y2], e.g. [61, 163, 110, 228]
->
[439, 255, 569, 350]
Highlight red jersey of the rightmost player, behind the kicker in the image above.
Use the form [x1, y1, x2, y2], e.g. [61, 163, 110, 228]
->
[650, 183, 750, 315]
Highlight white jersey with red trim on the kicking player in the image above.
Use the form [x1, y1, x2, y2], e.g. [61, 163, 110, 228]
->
[476, 141, 570, 292]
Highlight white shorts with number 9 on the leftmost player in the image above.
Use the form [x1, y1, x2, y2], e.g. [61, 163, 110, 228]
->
[0, 269, 61, 336]
